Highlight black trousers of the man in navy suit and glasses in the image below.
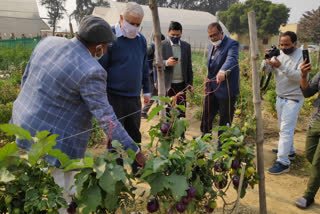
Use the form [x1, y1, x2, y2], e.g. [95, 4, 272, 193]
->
[200, 93, 236, 136]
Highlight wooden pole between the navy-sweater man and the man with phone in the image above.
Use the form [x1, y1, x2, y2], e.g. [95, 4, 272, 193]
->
[149, 0, 166, 118]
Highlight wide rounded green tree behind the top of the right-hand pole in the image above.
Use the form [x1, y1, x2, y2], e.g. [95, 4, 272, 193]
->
[220, 0, 290, 38]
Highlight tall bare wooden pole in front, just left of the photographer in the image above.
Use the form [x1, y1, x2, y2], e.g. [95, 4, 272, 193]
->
[248, 11, 267, 214]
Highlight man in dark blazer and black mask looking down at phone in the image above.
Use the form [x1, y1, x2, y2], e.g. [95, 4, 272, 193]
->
[162, 21, 193, 117]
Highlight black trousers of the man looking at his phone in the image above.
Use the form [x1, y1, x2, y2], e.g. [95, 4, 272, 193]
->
[166, 82, 187, 118]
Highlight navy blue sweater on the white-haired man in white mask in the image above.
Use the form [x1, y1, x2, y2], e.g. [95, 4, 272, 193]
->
[99, 27, 150, 97]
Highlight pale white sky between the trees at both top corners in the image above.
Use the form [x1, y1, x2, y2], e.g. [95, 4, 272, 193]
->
[37, 0, 320, 32]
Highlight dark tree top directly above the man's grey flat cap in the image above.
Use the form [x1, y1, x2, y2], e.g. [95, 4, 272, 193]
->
[72, 0, 109, 23]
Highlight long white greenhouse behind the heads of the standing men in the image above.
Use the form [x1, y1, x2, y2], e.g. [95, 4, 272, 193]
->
[93, 1, 229, 49]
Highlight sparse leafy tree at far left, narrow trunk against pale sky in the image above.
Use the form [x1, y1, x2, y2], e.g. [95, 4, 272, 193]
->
[40, 0, 66, 35]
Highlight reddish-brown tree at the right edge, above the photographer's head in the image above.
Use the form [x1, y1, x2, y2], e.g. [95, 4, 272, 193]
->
[298, 6, 320, 44]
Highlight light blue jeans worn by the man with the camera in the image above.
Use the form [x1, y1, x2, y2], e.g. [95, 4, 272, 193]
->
[276, 97, 303, 166]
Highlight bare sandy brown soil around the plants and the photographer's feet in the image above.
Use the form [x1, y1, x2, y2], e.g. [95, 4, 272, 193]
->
[89, 101, 320, 214]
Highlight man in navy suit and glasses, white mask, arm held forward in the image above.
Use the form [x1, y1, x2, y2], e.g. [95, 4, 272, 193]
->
[200, 23, 239, 144]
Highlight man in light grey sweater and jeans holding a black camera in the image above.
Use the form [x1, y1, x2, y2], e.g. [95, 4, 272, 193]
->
[262, 31, 303, 175]
